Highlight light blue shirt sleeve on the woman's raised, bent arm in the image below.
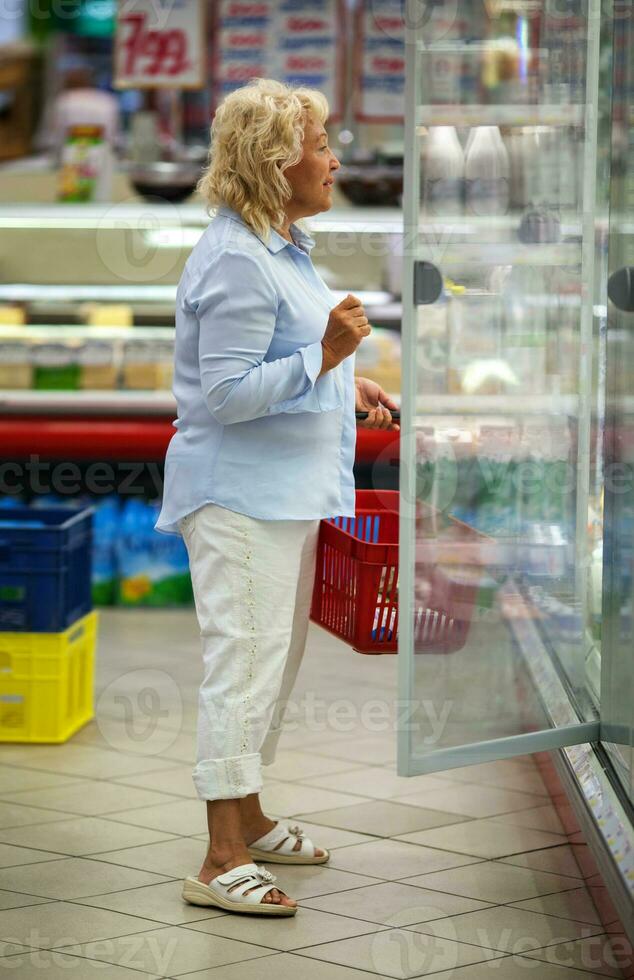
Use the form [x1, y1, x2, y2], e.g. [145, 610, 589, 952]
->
[189, 249, 322, 425]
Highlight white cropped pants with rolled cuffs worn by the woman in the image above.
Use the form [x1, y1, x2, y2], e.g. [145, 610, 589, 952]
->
[179, 504, 319, 800]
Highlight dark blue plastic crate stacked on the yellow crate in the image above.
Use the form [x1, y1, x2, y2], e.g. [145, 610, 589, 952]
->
[0, 507, 93, 633]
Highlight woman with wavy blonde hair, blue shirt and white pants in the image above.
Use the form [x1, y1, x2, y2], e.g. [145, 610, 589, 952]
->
[156, 79, 397, 915]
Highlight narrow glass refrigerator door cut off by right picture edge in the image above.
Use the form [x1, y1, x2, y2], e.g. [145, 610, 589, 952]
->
[601, 5, 634, 803]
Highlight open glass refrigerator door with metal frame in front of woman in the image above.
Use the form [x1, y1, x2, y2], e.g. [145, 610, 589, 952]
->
[398, 0, 611, 775]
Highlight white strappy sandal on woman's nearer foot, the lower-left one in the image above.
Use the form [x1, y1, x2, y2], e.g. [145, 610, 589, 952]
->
[182, 864, 297, 915]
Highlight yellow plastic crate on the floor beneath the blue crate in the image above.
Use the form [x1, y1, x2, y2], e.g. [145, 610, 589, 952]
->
[0, 612, 98, 742]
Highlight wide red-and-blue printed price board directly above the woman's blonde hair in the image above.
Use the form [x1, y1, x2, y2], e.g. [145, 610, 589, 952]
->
[212, 0, 345, 122]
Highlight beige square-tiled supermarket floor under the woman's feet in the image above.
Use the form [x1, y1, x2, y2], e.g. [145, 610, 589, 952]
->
[0, 610, 622, 980]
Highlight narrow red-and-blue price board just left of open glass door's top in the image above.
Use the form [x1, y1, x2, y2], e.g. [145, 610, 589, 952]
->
[354, 0, 405, 123]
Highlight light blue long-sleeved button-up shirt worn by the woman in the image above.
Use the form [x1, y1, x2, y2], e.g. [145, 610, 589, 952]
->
[155, 207, 356, 533]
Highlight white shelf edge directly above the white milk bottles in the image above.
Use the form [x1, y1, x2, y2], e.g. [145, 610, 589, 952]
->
[417, 103, 585, 126]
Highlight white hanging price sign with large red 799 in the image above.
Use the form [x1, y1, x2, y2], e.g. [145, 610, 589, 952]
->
[114, 0, 205, 89]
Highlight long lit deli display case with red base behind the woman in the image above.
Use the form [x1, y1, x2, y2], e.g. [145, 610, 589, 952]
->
[0, 204, 402, 466]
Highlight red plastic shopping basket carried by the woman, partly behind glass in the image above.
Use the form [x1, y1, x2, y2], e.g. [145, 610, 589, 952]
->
[310, 490, 482, 654]
